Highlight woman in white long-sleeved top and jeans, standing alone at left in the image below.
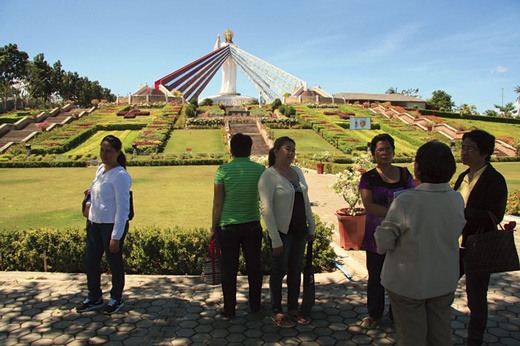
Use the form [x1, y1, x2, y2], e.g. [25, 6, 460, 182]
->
[76, 135, 132, 314]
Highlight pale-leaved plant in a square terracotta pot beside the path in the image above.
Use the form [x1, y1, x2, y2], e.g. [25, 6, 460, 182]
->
[332, 154, 374, 250]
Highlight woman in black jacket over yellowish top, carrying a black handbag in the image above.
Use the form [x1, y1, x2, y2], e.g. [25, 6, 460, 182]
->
[454, 130, 507, 346]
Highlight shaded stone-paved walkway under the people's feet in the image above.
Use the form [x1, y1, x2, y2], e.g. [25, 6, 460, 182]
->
[0, 171, 520, 346]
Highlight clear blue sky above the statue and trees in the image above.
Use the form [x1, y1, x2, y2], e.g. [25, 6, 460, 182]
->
[0, 0, 520, 112]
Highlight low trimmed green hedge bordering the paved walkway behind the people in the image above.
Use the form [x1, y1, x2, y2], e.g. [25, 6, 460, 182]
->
[0, 216, 335, 275]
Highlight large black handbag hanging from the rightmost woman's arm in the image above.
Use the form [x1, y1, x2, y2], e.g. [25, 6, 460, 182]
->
[466, 211, 520, 274]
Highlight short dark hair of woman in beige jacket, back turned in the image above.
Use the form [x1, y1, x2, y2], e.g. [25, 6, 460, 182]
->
[415, 141, 457, 184]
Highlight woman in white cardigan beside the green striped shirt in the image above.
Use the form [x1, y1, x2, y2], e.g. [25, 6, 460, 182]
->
[258, 137, 316, 328]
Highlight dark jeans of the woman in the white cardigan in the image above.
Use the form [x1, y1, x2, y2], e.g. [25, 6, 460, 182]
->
[269, 232, 308, 314]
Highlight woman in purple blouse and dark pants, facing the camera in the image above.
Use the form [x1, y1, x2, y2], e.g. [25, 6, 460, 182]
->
[359, 133, 415, 329]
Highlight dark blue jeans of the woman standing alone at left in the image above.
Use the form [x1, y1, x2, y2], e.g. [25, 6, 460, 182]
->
[85, 222, 128, 300]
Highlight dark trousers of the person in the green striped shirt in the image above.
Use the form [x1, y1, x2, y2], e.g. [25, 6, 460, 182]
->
[217, 221, 263, 316]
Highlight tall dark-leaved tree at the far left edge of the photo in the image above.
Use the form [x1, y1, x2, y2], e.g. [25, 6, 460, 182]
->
[0, 43, 29, 109]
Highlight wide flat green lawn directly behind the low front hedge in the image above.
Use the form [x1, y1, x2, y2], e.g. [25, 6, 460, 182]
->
[0, 163, 520, 229]
